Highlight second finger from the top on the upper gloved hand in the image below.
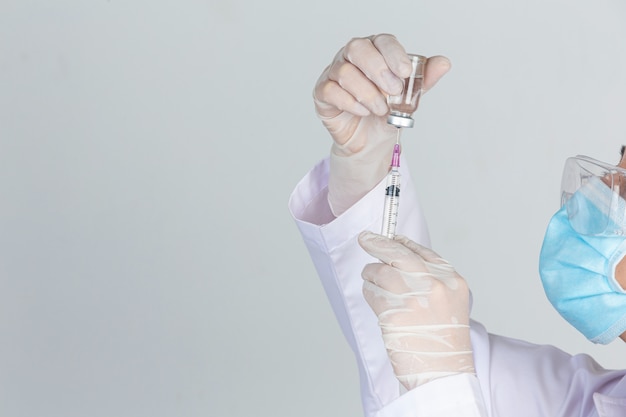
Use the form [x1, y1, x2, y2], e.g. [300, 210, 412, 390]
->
[341, 38, 408, 94]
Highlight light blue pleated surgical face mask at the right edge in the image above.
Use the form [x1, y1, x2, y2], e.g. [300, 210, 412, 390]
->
[539, 174, 626, 344]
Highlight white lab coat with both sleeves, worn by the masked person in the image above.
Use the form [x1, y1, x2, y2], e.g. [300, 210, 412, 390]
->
[289, 160, 626, 417]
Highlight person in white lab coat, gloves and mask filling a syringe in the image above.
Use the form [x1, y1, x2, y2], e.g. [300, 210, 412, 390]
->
[289, 34, 626, 417]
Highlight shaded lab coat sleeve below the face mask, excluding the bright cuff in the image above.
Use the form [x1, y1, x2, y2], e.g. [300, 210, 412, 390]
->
[472, 325, 626, 417]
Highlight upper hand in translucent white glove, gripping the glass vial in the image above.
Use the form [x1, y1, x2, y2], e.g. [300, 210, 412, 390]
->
[313, 34, 450, 216]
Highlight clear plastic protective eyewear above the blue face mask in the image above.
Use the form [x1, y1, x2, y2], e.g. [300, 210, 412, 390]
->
[561, 155, 626, 236]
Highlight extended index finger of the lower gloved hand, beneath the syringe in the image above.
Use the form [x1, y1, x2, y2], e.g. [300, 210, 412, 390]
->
[358, 231, 426, 272]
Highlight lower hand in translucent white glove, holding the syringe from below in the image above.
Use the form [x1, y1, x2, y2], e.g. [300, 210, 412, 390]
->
[359, 232, 475, 390]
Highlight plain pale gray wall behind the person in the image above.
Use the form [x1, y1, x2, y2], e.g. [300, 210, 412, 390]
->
[0, 0, 626, 417]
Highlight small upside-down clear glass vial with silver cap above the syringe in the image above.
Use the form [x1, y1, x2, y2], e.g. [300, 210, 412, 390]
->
[387, 54, 426, 128]
